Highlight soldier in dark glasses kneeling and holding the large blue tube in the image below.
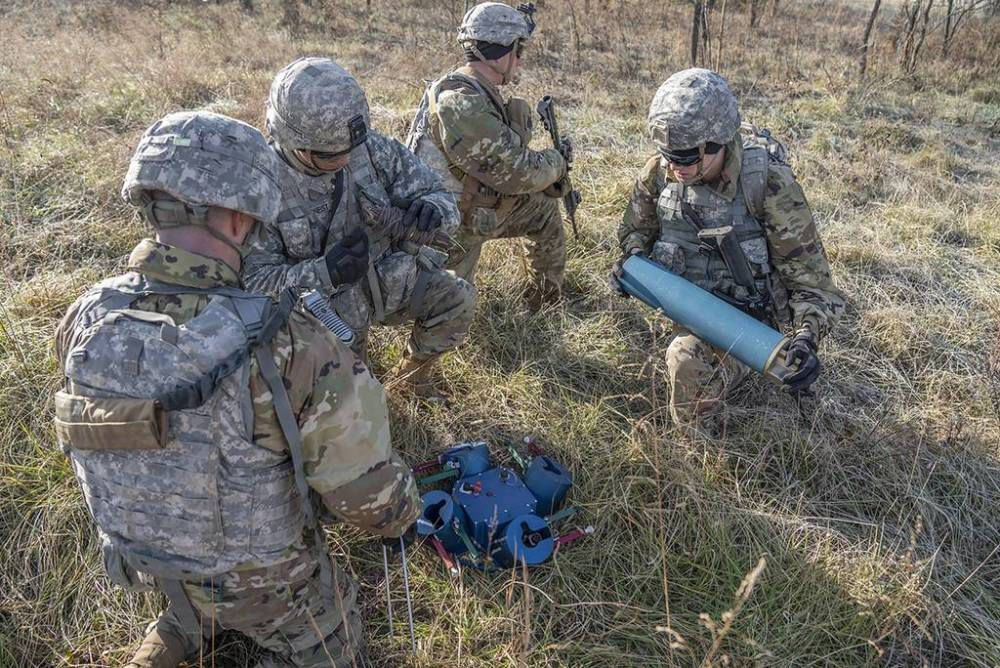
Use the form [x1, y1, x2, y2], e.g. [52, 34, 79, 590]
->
[612, 68, 844, 432]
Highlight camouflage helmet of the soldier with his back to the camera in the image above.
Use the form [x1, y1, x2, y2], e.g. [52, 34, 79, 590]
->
[122, 111, 281, 230]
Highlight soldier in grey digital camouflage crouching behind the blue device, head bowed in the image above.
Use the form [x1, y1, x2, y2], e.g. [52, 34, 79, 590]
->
[243, 58, 475, 395]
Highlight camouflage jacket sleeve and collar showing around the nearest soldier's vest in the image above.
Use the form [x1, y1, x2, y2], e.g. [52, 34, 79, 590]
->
[56, 239, 421, 540]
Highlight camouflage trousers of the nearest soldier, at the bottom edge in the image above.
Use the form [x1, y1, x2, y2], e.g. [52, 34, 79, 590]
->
[142, 549, 365, 668]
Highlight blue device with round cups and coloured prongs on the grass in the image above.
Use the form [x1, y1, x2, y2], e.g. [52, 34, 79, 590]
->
[416, 442, 593, 572]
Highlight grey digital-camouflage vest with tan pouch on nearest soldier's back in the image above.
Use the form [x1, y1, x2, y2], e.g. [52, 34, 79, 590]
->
[56, 273, 312, 580]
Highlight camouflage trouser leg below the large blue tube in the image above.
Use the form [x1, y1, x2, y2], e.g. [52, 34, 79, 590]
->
[667, 330, 750, 432]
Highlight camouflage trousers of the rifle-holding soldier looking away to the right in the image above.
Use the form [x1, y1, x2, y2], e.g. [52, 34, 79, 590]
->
[448, 193, 566, 290]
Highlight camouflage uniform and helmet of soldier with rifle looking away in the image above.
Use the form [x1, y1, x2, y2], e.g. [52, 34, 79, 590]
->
[407, 3, 566, 292]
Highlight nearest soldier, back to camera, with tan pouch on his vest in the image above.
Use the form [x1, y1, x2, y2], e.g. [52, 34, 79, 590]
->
[56, 112, 420, 668]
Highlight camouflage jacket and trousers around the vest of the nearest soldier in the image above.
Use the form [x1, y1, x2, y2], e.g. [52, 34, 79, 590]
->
[56, 239, 420, 666]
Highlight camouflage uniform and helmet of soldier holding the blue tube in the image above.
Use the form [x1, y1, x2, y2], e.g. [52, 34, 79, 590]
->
[618, 70, 844, 425]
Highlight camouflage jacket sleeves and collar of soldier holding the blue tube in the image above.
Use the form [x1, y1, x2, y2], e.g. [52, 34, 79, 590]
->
[618, 141, 844, 337]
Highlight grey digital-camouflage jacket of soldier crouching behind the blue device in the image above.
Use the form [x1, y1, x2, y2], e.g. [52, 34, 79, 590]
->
[242, 132, 459, 302]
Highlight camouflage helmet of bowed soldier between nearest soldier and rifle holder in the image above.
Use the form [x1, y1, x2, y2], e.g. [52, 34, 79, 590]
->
[267, 58, 370, 154]
